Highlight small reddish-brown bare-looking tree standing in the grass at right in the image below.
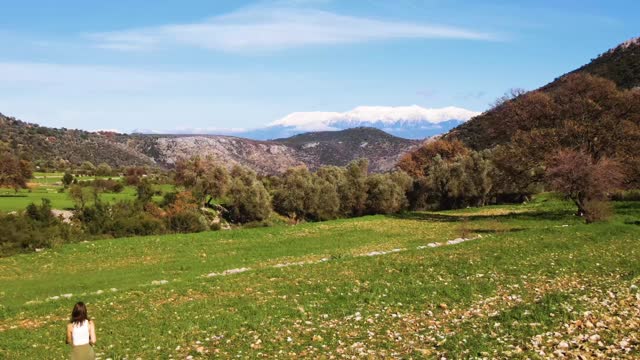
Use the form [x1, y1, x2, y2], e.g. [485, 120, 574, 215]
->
[546, 149, 624, 223]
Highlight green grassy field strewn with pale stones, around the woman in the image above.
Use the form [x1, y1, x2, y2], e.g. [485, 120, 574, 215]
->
[0, 195, 640, 359]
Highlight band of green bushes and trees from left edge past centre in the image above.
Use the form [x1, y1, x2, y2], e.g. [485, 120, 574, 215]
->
[0, 157, 412, 254]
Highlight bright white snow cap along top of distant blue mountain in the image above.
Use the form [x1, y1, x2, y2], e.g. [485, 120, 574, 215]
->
[269, 105, 480, 131]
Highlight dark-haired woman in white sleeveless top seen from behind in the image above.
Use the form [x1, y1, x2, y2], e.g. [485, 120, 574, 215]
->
[67, 302, 96, 360]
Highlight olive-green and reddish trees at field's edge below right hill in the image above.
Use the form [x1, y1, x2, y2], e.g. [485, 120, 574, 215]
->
[398, 136, 627, 222]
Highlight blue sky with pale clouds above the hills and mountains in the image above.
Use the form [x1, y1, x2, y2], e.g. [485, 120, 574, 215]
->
[0, 0, 640, 131]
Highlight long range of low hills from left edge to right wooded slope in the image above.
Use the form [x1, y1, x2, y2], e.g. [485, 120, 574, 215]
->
[0, 114, 419, 174]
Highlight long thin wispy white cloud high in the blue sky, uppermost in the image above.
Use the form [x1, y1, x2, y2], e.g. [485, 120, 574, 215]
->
[88, 7, 497, 52]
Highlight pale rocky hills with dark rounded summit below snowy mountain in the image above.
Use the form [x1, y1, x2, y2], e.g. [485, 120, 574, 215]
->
[132, 128, 420, 173]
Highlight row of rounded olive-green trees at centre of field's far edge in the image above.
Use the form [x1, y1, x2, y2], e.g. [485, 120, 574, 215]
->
[175, 157, 412, 223]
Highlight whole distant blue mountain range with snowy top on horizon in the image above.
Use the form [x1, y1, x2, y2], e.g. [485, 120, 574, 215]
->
[134, 105, 480, 140]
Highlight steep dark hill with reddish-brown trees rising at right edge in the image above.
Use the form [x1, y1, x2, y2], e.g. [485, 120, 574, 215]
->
[443, 38, 640, 150]
